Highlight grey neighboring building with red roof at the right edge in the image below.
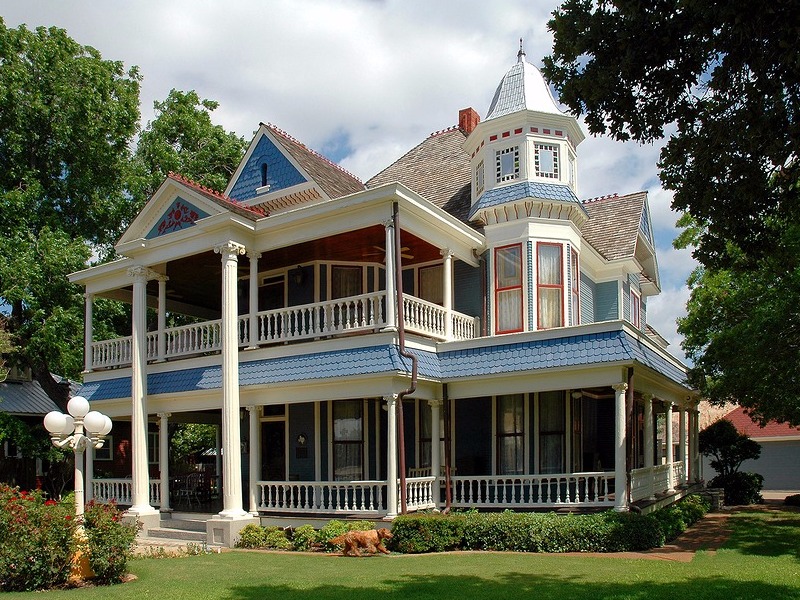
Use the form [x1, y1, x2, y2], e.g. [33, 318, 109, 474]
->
[703, 406, 800, 491]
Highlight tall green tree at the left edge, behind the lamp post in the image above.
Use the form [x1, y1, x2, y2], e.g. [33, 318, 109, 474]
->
[0, 19, 140, 407]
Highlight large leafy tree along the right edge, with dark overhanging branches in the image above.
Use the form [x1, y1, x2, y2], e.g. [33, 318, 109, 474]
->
[544, 0, 800, 424]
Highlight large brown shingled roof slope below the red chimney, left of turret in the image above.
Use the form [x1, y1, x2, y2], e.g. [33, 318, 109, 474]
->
[367, 127, 471, 222]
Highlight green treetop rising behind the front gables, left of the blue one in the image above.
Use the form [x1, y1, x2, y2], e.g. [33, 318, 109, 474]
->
[129, 89, 247, 210]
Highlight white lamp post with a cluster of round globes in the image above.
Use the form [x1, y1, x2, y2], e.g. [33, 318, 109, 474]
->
[44, 396, 111, 528]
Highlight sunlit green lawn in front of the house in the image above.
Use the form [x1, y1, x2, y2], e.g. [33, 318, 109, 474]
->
[0, 510, 800, 600]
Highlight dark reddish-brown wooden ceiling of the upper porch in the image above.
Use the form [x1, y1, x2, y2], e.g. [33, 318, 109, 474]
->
[153, 225, 442, 312]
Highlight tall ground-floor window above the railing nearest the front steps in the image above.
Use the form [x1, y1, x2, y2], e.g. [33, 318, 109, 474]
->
[333, 400, 364, 481]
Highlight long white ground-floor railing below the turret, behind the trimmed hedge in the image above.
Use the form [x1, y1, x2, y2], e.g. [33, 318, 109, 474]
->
[450, 472, 614, 508]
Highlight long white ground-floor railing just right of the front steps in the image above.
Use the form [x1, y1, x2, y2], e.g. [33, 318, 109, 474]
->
[257, 481, 386, 514]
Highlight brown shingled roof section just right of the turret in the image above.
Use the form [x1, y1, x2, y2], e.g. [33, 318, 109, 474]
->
[581, 192, 647, 260]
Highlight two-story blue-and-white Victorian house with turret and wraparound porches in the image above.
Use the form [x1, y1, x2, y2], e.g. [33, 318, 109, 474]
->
[71, 44, 699, 543]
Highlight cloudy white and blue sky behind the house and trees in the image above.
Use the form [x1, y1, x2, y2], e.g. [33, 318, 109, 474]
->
[0, 0, 696, 358]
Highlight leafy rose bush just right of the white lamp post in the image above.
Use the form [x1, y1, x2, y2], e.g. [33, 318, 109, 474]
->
[83, 500, 138, 584]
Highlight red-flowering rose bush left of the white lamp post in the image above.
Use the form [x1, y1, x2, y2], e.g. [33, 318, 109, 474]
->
[0, 484, 76, 591]
